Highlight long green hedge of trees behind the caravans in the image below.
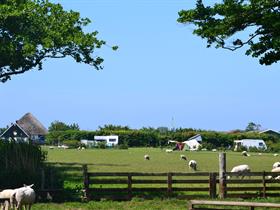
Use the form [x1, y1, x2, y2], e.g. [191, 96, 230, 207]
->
[46, 128, 280, 151]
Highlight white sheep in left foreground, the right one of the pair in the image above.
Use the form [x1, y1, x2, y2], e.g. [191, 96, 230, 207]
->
[11, 184, 36, 210]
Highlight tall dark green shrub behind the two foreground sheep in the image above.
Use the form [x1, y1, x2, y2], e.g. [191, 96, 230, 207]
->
[0, 141, 47, 189]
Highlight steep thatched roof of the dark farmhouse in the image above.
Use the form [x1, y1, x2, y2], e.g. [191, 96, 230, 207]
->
[16, 113, 48, 135]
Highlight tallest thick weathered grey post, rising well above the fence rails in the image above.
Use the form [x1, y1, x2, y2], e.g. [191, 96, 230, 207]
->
[219, 152, 226, 199]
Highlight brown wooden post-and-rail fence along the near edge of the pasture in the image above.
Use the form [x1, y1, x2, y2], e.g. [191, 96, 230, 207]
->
[83, 165, 280, 200]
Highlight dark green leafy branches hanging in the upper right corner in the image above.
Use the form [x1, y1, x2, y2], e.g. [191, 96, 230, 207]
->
[178, 0, 280, 65]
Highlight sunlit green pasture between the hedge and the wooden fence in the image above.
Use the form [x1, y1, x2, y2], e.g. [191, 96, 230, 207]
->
[44, 147, 280, 172]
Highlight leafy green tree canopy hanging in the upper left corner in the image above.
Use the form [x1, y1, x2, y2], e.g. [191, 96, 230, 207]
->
[0, 0, 116, 82]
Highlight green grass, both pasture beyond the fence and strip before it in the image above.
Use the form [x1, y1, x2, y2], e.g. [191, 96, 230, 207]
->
[37, 147, 280, 210]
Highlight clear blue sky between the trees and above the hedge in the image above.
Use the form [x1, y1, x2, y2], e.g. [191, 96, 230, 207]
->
[0, 0, 280, 131]
